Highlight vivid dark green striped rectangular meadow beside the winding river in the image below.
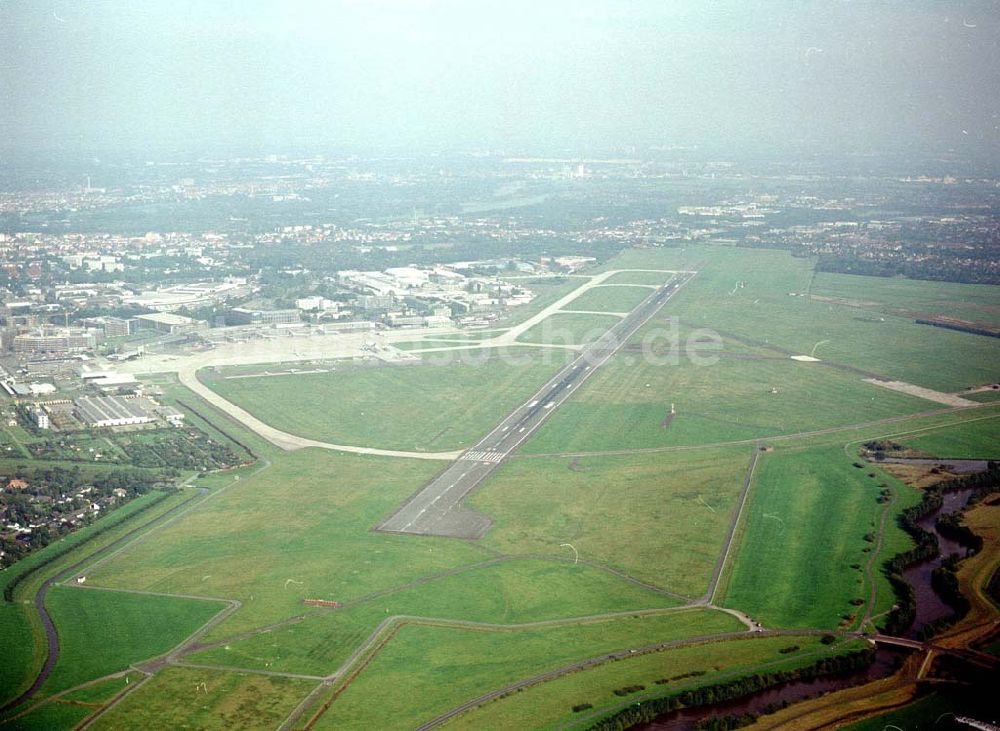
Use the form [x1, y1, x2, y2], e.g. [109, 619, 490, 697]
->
[720, 448, 905, 629]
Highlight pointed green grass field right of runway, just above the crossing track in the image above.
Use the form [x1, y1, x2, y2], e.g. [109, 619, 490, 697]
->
[524, 353, 928, 454]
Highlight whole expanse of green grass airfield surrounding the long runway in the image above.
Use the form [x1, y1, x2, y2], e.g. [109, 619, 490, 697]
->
[0, 247, 1000, 728]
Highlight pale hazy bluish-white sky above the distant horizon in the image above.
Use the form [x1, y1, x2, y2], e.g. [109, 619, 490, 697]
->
[0, 0, 1000, 155]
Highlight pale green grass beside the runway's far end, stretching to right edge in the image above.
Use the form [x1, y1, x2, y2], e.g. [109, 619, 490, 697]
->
[623, 247, 1000, 391]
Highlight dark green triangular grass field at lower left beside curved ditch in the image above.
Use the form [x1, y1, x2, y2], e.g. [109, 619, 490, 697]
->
[42, 586, 226, 694]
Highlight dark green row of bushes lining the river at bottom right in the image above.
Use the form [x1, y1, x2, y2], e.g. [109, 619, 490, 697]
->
[590, 648, 875, 731]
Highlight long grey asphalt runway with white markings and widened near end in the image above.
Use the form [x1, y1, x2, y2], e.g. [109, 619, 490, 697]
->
[376, 273, 694, 539]
